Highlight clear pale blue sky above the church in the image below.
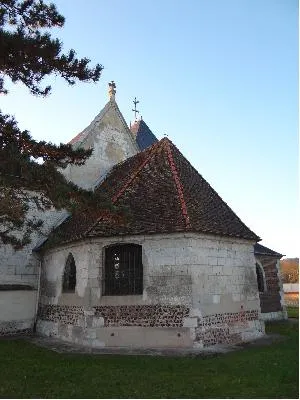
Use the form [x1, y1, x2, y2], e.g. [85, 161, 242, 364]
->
[1, 0, 299, 257]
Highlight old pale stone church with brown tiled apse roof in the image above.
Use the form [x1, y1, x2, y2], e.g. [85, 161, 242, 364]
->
[0, 82, 286, 348]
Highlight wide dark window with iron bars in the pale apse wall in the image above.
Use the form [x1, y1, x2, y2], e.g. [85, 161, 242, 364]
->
[104, 244, 143, 295]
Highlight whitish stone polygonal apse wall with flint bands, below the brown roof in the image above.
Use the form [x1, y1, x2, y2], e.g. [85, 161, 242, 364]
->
[37, 234, 264, 347]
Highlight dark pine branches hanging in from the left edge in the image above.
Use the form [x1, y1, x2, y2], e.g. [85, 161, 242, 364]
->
[0, 0, 105, 249]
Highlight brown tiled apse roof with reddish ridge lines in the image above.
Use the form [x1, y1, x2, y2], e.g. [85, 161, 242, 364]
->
[44, 138, 260, 248]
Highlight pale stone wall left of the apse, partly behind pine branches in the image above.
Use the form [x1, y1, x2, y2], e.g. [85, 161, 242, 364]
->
[0, 192, 66, 335]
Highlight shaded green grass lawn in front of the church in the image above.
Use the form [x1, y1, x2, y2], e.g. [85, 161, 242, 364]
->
[0, 323, 298, 398]
